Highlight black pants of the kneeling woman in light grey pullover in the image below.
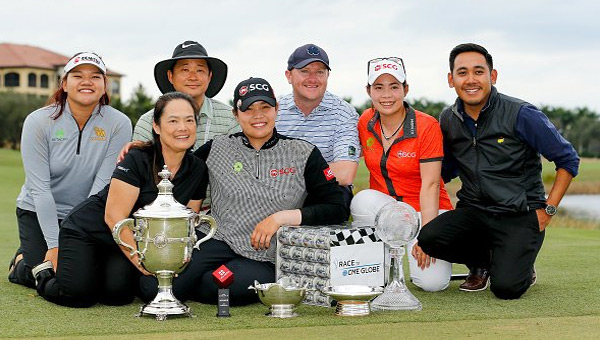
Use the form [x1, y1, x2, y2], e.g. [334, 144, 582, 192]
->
[8, 208, 56, 288]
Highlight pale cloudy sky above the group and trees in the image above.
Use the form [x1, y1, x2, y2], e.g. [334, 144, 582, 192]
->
[0, 0, 600, 113]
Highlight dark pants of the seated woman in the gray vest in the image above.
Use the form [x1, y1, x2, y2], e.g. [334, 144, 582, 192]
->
[140, 232, 275, 306]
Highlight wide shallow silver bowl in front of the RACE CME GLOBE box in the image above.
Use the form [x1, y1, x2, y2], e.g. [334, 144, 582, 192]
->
[321, 285, 383, 316]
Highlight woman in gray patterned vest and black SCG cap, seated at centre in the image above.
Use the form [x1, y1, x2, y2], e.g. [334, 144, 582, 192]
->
[141, 78, 349, 305]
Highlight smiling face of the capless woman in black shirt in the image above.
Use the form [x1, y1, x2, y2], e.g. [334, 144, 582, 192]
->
[152, 99, 196, 152]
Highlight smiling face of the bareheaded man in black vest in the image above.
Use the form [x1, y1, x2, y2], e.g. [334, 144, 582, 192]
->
[448, 52, 498, 118]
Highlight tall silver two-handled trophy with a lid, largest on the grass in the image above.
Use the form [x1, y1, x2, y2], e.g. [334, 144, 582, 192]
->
[113, 165, 217, 321]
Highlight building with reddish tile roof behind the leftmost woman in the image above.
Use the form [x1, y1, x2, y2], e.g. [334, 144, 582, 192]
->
[0, 43, 123, 97]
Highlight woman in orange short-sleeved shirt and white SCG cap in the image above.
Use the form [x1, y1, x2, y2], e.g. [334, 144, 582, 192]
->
[358, 57, 452, 291]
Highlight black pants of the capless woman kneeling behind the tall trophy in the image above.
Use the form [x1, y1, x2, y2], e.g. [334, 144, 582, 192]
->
[40, 202, 141, 307]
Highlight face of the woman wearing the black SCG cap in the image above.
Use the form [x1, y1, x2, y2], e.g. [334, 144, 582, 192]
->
[235, 100, 278, 150]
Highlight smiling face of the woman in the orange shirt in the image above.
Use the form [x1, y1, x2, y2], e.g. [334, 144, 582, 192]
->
[367, 73, 408, 116]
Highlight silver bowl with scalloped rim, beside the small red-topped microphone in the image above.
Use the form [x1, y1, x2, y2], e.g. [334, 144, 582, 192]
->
[248, 277, 307, 318]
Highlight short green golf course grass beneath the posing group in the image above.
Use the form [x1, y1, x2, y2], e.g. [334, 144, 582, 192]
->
[0, 150, 600, 340]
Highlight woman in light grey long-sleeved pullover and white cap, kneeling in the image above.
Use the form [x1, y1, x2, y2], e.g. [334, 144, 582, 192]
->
[9, 52, 131, 287]
